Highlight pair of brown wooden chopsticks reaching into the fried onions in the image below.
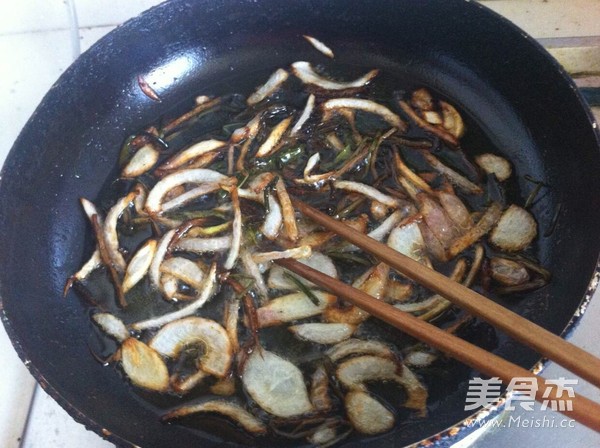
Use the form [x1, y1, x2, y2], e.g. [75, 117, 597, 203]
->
[276, 199, 600, 431]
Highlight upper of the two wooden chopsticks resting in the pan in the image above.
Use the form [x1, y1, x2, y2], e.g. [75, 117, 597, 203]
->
[292, 199, 600, 387]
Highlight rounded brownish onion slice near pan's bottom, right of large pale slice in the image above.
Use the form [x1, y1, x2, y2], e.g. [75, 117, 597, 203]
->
[344, 390, 396, 435]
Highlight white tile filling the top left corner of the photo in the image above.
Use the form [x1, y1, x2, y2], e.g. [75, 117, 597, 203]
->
[0, 0, 70, 34]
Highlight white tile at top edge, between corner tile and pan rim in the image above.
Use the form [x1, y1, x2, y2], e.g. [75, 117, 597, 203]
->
[75, 0, 164, 27]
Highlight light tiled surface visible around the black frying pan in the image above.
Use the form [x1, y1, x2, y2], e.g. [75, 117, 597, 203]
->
[0, 0, 600, 448]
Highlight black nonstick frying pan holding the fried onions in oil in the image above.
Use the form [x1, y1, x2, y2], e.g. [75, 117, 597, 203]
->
[0, 0, 600, 447]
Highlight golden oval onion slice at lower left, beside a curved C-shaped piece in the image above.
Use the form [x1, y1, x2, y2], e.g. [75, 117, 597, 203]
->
[121, 338, 169, 392]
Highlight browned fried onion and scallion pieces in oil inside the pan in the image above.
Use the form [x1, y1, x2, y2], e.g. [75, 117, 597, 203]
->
[65, 51, 550, 446]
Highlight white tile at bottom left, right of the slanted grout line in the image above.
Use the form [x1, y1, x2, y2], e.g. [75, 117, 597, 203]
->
[20, 387, 114, 448]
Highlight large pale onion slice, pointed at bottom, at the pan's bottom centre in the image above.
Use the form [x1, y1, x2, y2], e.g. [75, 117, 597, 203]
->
[242, 349, 313, 418]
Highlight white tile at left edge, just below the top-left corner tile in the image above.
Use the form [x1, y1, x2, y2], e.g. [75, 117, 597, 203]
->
[0, 30, 72, 165]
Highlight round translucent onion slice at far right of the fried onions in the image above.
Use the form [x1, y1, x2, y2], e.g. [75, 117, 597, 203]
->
[490, 204, 537, 252]
